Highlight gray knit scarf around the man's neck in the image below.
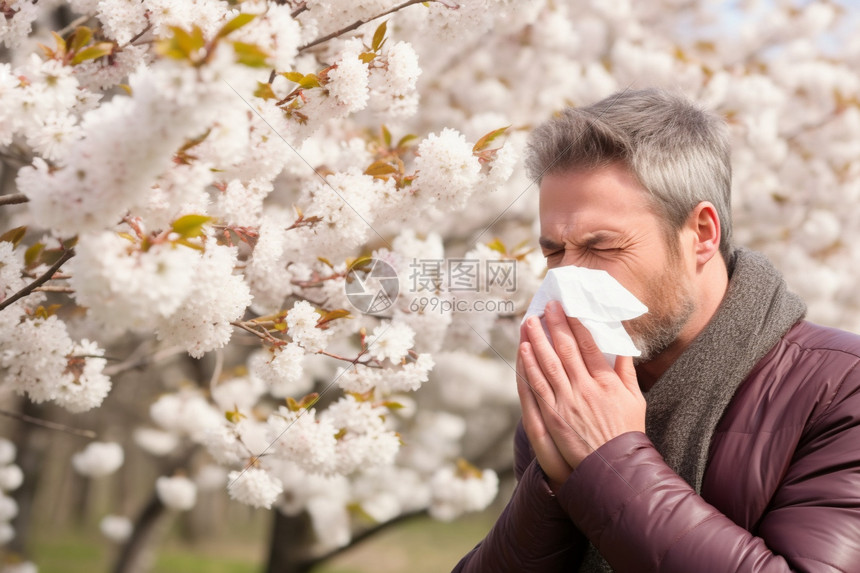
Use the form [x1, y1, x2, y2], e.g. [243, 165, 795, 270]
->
[579, 249, 806, 573]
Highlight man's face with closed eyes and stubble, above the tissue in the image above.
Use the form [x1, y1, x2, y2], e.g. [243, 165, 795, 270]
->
[540, 164, 696, 362]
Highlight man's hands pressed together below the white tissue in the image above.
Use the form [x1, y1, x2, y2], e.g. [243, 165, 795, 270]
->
[518, 302, 645, 470]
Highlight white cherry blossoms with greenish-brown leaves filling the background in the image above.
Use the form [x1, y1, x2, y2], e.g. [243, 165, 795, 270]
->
[0, 0, 860, 571]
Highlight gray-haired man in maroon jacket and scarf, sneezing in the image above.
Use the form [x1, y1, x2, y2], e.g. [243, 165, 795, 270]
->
[455, 90, 860, 573]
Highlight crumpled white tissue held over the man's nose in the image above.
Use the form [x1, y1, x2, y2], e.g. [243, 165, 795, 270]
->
[523, 265, 648, 364]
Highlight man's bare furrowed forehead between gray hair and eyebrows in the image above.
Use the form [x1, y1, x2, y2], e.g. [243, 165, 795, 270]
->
[540, 165, 658, 234]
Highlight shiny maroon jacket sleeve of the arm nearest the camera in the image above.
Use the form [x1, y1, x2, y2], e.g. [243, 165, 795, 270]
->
[559, 374, 860, 573]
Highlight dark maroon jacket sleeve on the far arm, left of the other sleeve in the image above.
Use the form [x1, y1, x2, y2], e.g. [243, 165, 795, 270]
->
[454, 418, 587, 573]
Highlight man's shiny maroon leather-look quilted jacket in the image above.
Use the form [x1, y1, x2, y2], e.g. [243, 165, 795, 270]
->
[454, 321, 860, 573]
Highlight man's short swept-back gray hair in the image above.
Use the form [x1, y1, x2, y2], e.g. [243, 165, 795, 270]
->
[526, 89, 732, 263]
